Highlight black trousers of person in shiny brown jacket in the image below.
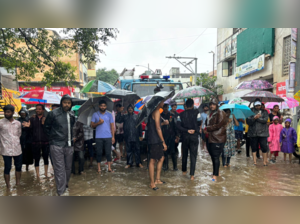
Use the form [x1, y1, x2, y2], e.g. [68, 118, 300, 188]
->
[207, 143, 225, 176]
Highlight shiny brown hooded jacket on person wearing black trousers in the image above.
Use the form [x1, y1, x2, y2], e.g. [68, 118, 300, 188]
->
[205, 98, 227, 143]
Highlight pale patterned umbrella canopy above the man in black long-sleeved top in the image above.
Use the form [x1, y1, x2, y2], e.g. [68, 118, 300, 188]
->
[172, 86, 215, 100]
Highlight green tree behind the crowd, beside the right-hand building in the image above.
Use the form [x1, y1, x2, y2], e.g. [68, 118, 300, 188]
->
[196, 73, 224, 102]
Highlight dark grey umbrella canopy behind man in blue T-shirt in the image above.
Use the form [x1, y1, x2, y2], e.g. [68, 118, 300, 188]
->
[78, 96, 114, 125]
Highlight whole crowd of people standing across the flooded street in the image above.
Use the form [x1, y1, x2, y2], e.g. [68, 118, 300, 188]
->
[0, 95, 300, 195]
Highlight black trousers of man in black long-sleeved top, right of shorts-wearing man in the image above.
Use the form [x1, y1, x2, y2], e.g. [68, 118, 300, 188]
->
[182, 134, 199, 176]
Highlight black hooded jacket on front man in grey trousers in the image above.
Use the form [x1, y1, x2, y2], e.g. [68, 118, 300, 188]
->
[44, 95, 75, 147]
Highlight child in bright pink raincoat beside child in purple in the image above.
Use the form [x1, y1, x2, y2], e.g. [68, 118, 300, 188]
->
[268, 116, 283, 162]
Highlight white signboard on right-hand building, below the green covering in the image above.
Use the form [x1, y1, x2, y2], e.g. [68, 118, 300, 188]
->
[235, 54, 265, 79]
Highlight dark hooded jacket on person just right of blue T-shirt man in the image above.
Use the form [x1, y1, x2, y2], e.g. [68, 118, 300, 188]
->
[118, 105, 143, 142]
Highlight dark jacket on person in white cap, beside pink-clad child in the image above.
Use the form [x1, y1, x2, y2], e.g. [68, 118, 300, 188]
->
[247, 108, 269, 138]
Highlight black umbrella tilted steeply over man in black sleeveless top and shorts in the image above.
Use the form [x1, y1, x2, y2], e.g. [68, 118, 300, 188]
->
[137, 91, 175, 126]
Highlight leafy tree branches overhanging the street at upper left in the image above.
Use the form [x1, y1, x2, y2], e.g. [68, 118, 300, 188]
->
[0, 28, 118, 86]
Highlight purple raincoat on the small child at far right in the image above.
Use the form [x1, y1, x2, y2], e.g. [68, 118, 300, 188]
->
[280, 127, 297, 153]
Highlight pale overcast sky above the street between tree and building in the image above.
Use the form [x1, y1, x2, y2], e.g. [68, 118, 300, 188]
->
[96, 28, 217, 75]
